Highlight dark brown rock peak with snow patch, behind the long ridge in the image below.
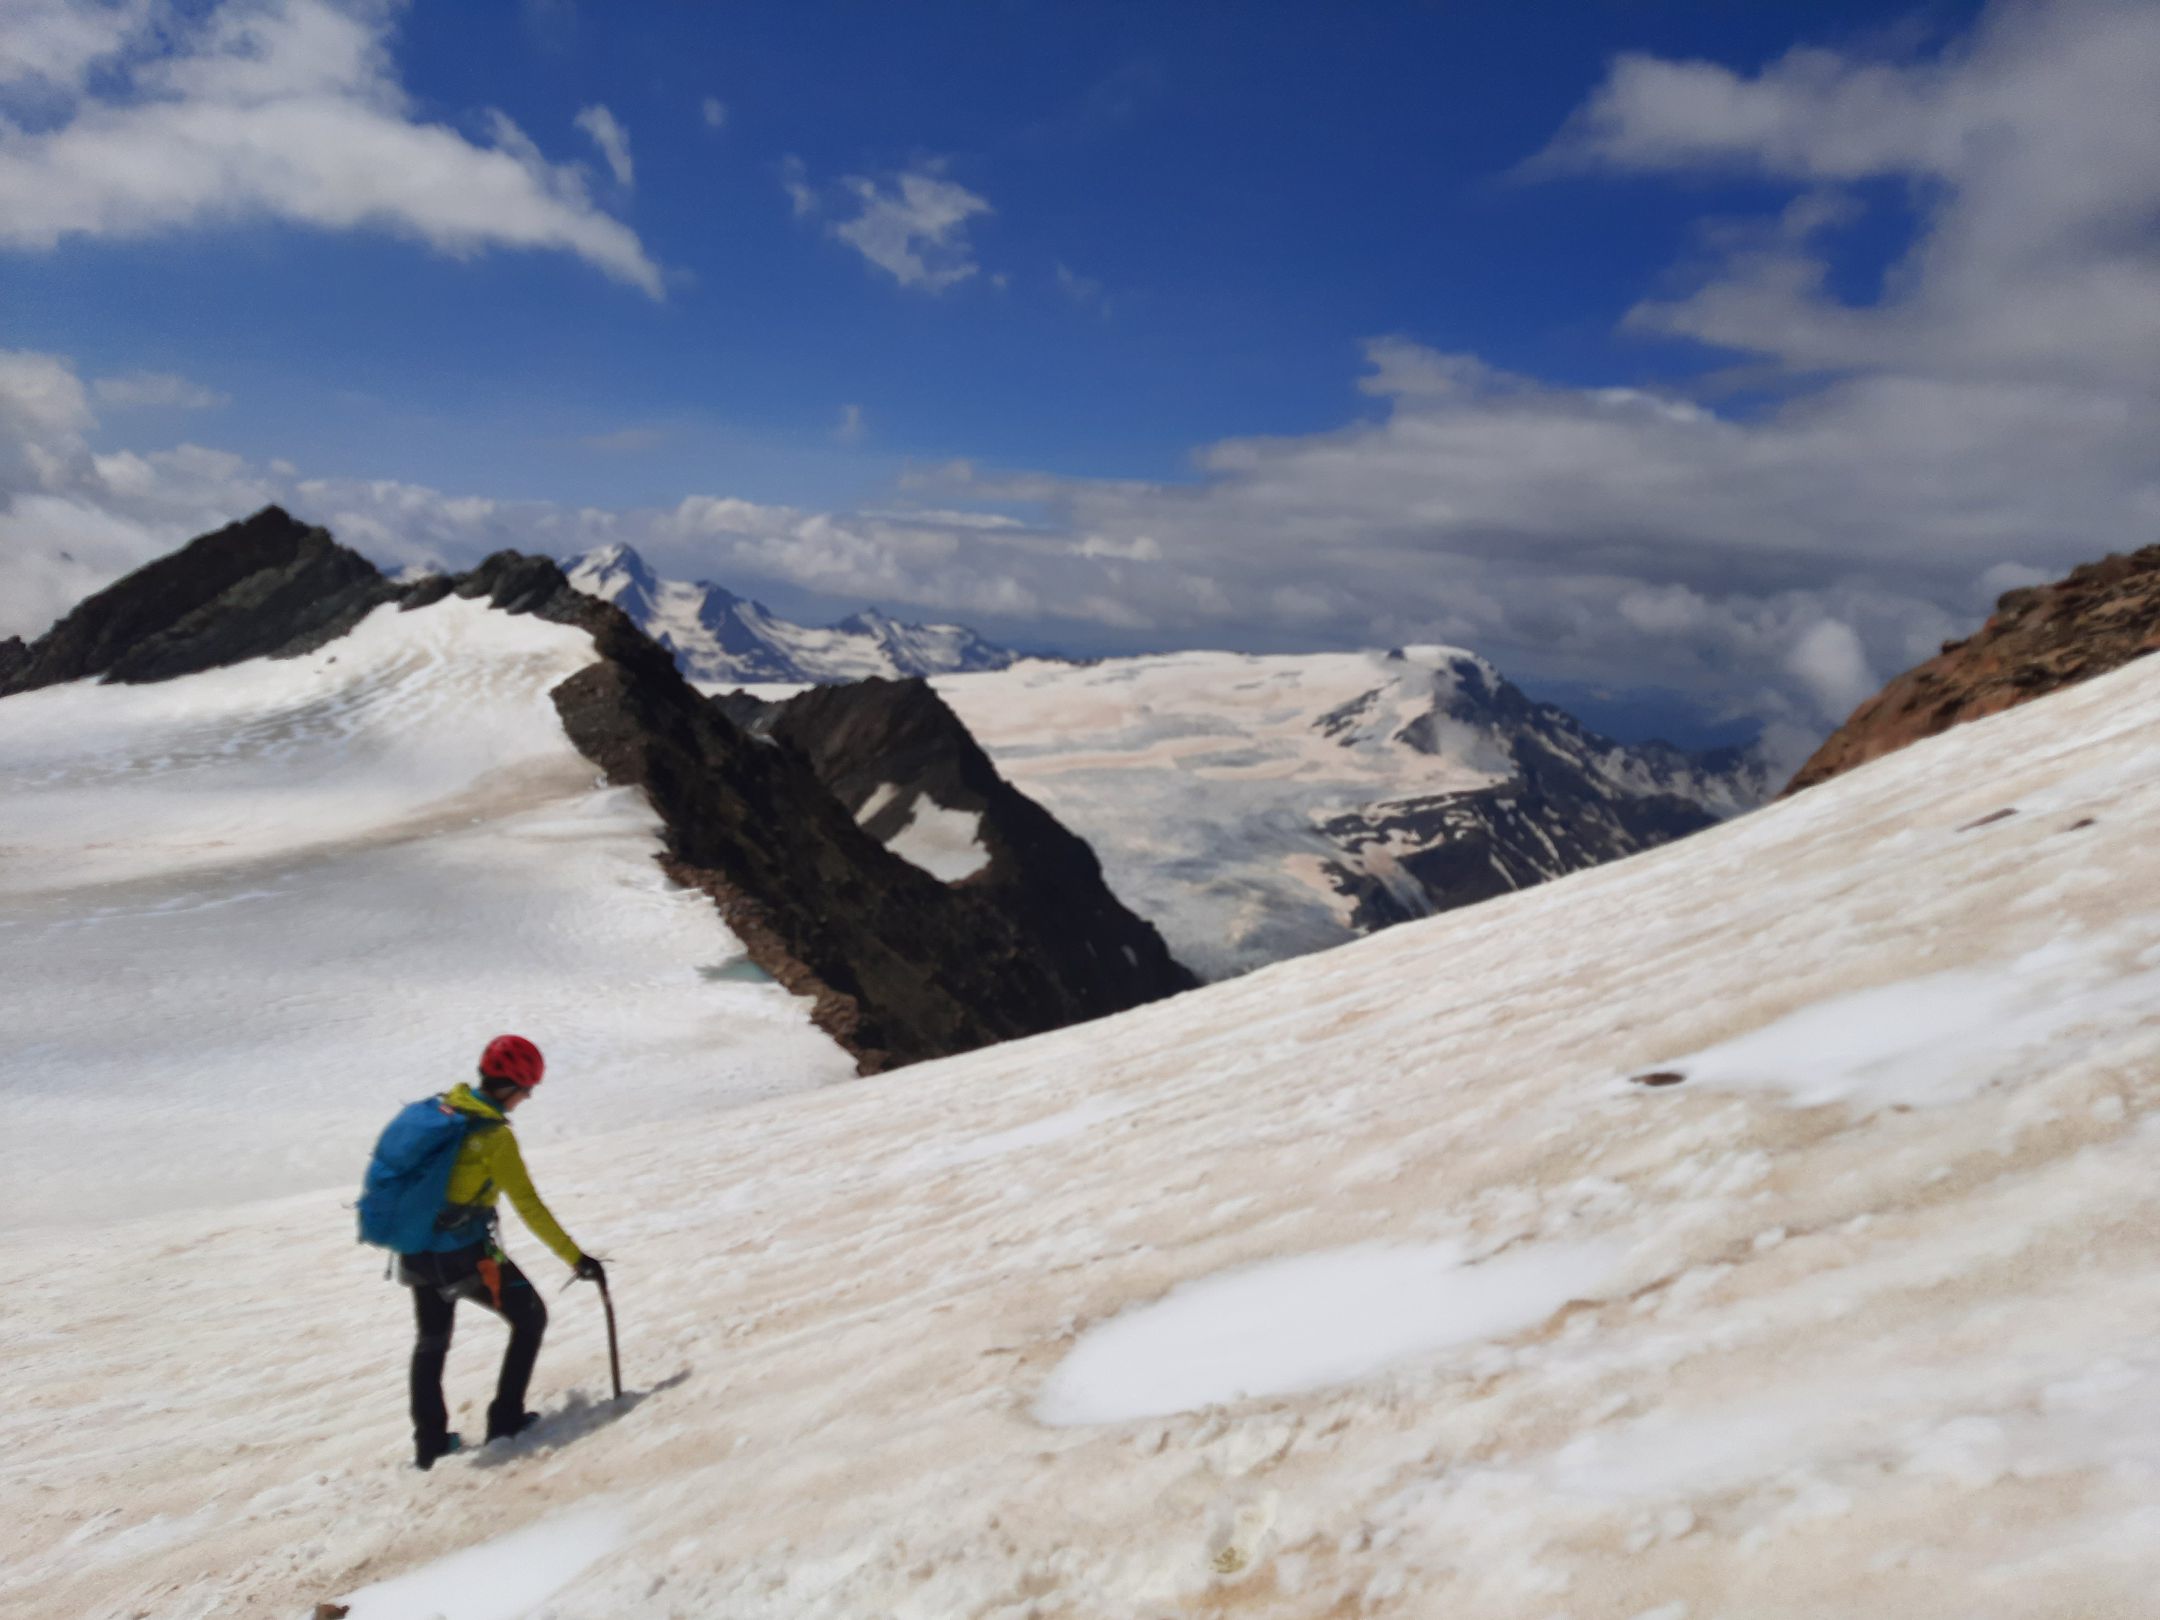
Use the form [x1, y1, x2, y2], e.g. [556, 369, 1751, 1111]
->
[719, 678, 1199, 1022]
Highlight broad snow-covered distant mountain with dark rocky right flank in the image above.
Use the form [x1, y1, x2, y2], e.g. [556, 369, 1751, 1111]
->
[937, 648, 1771, 978]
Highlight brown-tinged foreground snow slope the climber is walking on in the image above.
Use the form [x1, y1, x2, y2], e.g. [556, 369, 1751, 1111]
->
[0, 659, 2160, 1620]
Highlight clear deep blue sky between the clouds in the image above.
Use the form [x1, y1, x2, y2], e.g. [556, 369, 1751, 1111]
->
[4, 0, 1944, 505]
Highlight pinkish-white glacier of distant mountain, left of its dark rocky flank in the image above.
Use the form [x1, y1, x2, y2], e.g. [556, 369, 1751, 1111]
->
[933, 646, 1702, 978]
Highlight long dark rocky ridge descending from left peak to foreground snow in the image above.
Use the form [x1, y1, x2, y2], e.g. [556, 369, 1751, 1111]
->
[0, 508, 1190, 1071]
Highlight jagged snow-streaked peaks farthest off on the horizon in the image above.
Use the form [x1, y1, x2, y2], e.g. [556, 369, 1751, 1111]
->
[564, 544, 1017, 685]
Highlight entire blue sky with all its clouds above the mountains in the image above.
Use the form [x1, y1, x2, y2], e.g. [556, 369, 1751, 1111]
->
[0, 0, 2160, 734]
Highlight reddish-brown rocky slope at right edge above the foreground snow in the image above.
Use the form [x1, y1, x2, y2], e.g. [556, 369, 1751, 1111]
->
[1784, 546, 2160, 793]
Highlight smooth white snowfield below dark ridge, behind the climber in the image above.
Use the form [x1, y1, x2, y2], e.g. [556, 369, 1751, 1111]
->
[0, 598, 851, 1229]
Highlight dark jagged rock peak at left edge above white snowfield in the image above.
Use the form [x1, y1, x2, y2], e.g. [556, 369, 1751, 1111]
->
[0, 505, 397, 698]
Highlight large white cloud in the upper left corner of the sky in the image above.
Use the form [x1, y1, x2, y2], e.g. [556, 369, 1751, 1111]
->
[0, 0, 663, 298]
